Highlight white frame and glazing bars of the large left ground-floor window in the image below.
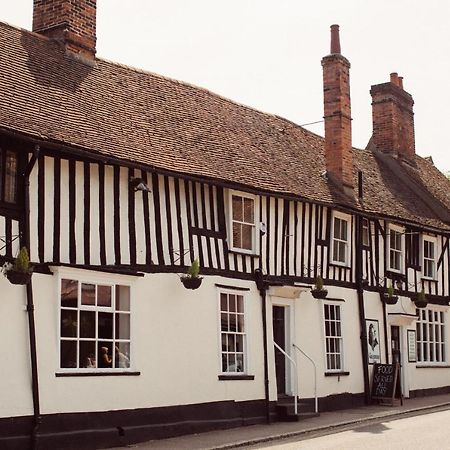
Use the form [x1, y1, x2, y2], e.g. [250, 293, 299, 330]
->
[56, 267, 136, 373]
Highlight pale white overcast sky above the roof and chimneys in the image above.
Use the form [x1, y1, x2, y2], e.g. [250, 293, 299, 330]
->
[0, 0, 450, 172]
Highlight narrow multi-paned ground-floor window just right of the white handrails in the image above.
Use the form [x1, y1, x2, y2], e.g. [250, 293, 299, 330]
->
[324, 303, 343, 372]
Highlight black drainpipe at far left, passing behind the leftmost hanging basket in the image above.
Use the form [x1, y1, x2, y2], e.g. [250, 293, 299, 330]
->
[22, 145, 41, 450]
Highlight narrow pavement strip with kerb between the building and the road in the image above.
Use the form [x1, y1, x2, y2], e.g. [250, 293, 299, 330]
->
[116, 394, 450, 450]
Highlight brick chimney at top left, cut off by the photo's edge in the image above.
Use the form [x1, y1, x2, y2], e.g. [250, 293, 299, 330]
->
[33, 0, 97, 59]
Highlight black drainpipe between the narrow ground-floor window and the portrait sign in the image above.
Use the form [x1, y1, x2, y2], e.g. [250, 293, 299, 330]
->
[355, 171, 370, 404]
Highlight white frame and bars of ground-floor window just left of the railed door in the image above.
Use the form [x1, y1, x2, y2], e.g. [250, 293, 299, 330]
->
[217, 288, 249, 375]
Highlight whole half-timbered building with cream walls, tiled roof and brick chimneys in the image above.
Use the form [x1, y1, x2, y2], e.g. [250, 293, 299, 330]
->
[0, 0, 450, 448]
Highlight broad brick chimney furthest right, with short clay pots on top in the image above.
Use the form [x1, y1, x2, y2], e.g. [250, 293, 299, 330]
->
[370, 73, 416, 161]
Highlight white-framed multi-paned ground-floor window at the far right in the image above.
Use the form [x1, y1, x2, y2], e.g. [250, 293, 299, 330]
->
[416, 306, 447, 366]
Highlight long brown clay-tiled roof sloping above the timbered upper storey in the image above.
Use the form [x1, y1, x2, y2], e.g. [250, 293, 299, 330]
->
[0, 24, 450, 229]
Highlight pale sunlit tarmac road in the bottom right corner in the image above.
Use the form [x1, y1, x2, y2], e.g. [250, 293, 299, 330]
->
[244, 409, 450, 450]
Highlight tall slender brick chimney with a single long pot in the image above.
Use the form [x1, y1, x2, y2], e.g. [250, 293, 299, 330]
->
[322, 25, 354, 195]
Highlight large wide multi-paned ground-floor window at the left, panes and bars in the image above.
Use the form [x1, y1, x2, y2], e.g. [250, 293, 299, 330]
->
[60, 278, 131, 370]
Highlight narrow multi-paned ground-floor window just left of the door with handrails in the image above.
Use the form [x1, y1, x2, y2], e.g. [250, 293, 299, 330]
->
[219, 292, 247, 373]
